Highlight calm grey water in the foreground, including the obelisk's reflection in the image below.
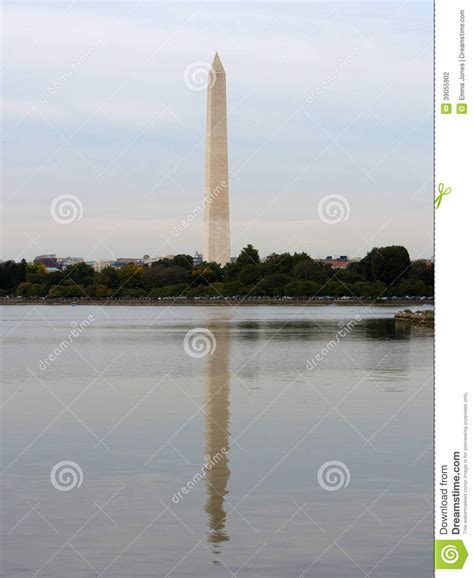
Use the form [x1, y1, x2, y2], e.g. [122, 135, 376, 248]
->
[2, 306, 433, 578]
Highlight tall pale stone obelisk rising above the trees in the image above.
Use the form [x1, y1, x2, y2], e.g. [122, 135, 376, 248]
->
[203, 52, 230, 265]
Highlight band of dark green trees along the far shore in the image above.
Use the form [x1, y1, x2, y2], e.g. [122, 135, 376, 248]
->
[0, 245, 434, 300]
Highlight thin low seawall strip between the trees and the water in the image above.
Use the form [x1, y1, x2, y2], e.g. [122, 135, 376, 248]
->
[0, 298, 434, 307]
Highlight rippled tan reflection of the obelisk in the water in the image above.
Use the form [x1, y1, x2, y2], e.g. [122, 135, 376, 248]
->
[203, 317, 230, 554]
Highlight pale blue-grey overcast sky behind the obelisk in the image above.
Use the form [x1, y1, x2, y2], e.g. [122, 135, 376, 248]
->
[2, 1, 433, 259]
